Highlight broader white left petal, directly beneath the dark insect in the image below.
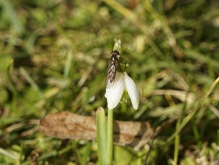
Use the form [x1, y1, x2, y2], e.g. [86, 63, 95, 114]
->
[105, 72, 125, 110]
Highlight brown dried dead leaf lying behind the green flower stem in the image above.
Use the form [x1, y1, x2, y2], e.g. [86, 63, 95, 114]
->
[40, 111, 156, 150]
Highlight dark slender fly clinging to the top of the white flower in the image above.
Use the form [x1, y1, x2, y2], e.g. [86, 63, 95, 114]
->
[106, 50, 120, 88]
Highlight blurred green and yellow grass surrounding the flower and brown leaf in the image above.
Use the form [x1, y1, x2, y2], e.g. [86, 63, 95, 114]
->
[0, 0, 219, 165]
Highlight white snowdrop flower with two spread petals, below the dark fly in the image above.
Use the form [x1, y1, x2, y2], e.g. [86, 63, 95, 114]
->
[105, 72, 139, 110]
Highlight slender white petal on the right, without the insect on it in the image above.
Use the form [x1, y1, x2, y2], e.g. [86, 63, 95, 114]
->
[124, 72, 139, 110]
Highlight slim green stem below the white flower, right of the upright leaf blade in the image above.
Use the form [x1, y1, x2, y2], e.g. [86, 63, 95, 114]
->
[107, 110, 113, 165]
